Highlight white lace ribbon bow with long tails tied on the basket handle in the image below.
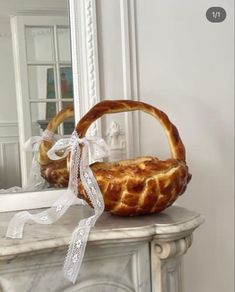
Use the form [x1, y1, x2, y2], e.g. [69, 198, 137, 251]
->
[6, 131, 108, 283]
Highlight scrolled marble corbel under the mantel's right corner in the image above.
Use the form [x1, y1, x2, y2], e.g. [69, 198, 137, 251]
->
[154, 234, 193, 259]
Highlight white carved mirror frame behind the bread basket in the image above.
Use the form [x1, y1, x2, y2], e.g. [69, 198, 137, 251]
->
[0, 0, 101, 212]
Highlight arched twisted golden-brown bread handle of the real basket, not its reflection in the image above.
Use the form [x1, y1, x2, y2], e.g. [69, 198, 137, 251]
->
[76, 100, 185, 161]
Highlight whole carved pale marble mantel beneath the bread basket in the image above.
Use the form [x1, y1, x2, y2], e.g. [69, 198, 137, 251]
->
[0, 205, 203, 292]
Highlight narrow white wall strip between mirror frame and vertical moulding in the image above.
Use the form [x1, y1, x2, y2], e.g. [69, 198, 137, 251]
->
[97, 0, 130, 159]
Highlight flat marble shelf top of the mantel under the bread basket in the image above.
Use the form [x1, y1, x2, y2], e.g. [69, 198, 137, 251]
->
[0, 205, 204, 260]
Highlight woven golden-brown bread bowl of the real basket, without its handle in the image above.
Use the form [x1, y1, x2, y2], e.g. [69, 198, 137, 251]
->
[78, 157, 191, 216]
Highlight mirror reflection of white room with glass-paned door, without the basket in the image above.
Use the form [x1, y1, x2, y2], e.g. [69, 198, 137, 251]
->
[0, 0, 74, 189]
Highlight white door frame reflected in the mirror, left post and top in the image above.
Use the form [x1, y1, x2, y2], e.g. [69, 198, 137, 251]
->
[11, 15, 68, 186]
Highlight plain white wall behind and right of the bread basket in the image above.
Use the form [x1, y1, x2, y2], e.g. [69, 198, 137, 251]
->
[97, 0, 234, 292]
